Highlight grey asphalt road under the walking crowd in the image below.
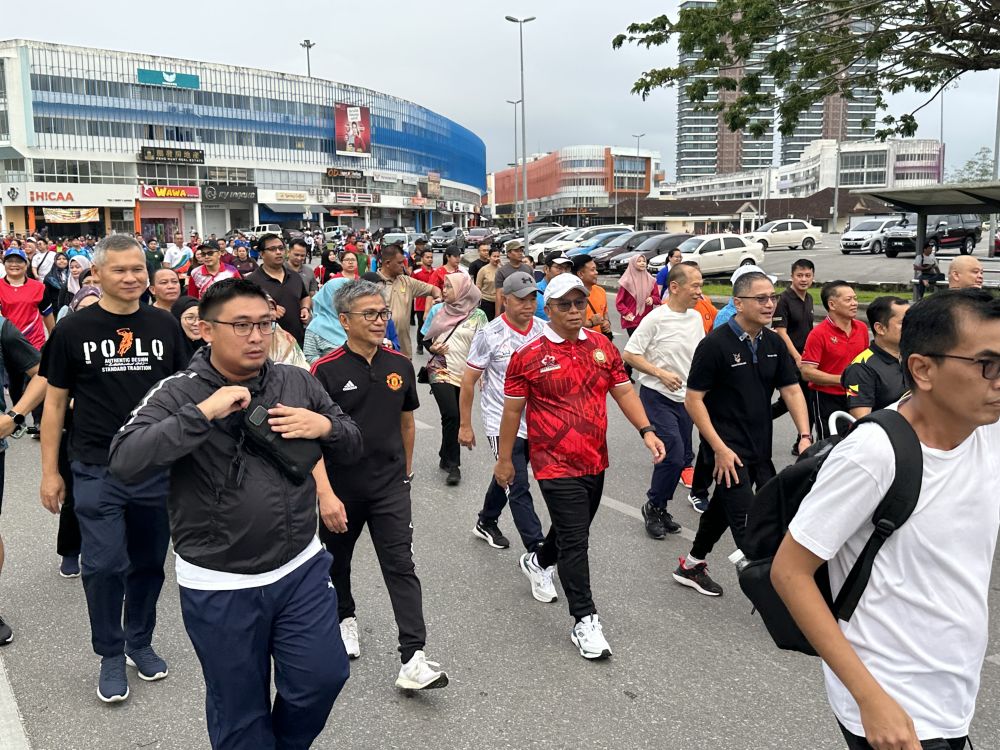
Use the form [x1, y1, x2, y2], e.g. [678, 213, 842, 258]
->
[0, 334, 1000, 750]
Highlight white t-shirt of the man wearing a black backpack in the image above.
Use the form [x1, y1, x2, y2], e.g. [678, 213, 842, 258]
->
[789, 405, 1000, 740]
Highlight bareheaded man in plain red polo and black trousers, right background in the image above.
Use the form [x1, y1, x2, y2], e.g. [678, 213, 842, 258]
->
[799, 281, 868, 440]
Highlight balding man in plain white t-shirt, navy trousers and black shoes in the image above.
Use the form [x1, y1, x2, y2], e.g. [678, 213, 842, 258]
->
[622, 263, 705, 539]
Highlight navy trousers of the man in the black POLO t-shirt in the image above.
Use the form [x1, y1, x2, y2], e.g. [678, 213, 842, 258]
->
[71, 461, 170, 656]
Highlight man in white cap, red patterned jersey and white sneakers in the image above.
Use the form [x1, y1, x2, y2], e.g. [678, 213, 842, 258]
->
[493, 273, 666, 659]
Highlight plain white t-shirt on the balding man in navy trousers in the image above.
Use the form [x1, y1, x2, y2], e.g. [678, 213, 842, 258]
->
[625, 305, 705, 403]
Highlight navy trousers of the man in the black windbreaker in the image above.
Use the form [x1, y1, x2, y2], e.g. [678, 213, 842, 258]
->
[180, 551, 350, 750]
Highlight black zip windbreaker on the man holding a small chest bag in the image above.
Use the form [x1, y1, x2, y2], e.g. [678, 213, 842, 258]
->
[109, 346, 362, 574]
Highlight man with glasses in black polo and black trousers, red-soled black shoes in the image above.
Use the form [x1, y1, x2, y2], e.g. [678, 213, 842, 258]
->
[673, 272, 812, 596]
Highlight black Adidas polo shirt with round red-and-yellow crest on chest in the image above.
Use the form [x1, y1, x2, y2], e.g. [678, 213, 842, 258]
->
[313, 344, 420, 500]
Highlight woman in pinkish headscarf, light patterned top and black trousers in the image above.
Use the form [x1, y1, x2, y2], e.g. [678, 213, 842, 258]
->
[420, 271, 489, 487]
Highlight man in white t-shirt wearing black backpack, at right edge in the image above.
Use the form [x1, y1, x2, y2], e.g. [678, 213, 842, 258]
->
[771, 289, 1000, 750]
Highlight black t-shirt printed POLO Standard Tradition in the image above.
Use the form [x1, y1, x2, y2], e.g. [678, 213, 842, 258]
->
[41, 304, 189, 466]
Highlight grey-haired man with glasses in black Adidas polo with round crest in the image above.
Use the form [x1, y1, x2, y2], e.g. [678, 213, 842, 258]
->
[313, 280, 448, 690]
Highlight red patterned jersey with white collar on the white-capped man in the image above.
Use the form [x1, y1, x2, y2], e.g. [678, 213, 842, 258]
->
[504, 326, 629, 479]
